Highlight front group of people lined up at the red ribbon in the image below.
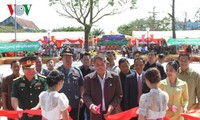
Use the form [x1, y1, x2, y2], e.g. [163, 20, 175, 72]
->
[1, 47, 200, 120]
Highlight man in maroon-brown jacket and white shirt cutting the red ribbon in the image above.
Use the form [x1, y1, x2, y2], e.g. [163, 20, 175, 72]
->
[83, 54, 122, 120]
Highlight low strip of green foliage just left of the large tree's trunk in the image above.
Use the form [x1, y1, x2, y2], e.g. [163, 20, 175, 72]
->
[52, 26, 84, 32]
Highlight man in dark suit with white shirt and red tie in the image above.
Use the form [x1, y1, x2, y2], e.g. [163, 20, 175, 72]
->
[124, 57, 150, 120]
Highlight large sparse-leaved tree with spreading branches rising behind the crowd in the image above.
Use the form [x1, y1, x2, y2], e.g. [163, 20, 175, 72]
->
[49, 0, 136, 51]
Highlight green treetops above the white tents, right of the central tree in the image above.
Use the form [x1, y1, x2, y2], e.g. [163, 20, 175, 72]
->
[117, 16, 170, 35]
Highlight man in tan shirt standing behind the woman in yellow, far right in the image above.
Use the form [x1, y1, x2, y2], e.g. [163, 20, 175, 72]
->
[177, 53, 200, 110]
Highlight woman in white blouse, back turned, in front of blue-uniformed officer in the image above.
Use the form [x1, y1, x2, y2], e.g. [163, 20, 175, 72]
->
[39, 70, 69, 120]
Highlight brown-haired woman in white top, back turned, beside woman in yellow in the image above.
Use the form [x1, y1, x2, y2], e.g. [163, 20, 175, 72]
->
[137, 68, 169, 120]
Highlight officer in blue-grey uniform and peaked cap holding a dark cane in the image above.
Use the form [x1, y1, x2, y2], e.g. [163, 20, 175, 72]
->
[58, 47, 83, 120]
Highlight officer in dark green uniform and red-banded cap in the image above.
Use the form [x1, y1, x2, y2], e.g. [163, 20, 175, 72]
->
[11, 57, 47, 120]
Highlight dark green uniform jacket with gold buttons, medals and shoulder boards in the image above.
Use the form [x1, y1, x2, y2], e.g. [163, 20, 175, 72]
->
[12, 74, 47, 120]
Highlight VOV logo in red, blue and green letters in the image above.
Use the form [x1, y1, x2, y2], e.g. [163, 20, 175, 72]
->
[7, 4, 32, 16]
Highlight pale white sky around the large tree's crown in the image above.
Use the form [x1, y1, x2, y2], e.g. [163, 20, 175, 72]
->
[0, 0, 200, 33]
